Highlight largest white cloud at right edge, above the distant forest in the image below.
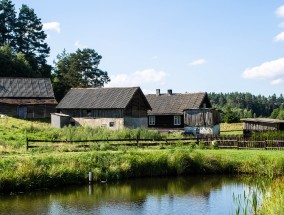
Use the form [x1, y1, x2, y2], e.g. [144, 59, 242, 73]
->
[242, 58, 284, 80]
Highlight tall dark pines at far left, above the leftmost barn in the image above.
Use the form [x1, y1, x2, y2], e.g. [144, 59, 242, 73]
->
[0, 0, 51, 77]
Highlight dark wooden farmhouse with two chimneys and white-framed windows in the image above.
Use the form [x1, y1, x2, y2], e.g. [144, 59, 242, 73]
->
[146, 89, 220, 135]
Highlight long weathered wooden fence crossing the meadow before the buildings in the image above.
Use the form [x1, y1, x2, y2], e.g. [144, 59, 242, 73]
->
[26, 135, 284, 150]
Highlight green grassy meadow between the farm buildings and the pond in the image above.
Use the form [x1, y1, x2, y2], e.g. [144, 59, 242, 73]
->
[0, 117, 284, 214]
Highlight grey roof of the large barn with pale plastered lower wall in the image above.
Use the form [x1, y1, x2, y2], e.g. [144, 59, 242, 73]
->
[56, 87, 151, 109]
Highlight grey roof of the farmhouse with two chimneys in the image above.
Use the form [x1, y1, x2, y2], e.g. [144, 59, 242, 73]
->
[146, 92, 211, 115]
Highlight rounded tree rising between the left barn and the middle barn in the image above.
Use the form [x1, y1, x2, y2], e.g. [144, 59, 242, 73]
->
[53, 48, 110, 100]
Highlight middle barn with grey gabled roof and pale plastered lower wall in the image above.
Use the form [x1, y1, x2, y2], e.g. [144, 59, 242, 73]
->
[56, 87, 151, 129]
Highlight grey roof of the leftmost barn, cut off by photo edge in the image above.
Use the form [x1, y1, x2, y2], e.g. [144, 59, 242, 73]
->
[0, 78, 54, 98]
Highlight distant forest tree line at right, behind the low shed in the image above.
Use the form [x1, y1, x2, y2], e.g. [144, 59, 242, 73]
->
[208, 92, 284, 123]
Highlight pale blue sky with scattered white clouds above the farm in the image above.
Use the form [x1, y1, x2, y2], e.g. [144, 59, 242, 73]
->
[12, 0, 284, 96]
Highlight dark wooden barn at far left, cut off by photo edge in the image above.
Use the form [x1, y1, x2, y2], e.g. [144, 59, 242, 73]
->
[0, 78, 57, 119]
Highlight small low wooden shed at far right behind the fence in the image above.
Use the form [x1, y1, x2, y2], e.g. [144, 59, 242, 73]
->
[241, 118, 284, 134]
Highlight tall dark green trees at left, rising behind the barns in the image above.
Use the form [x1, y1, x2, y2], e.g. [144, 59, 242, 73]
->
[0, 0, 110, 101]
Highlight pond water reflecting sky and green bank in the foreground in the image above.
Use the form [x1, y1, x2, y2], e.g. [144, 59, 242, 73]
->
[0, 176, 262, 215]
